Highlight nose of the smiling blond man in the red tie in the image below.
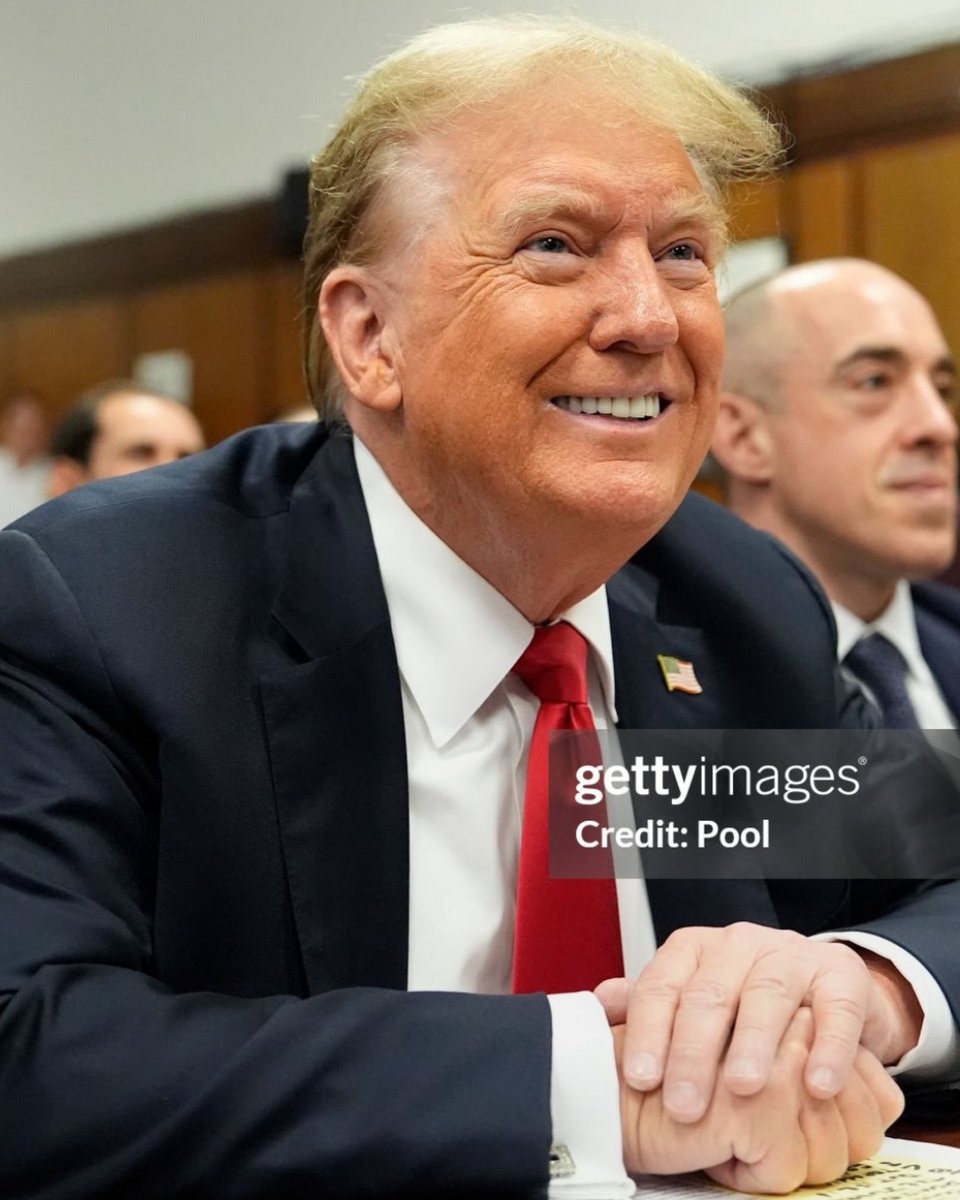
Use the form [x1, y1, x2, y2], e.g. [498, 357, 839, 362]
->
[589, 248, 680, 354]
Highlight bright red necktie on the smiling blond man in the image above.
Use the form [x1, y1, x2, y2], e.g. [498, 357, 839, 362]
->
[514, 622, 623, 992]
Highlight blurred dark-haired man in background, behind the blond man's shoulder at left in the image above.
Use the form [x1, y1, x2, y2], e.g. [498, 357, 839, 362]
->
[49, 379, 204, 496]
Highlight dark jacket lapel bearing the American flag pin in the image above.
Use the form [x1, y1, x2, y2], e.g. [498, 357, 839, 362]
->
[607, 568, 779, 943]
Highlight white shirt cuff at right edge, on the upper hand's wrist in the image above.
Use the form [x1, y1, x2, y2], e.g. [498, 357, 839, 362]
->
[811, 930, 960, 1080]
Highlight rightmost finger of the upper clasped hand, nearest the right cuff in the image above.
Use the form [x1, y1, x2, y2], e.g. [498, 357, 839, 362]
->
[804, 944, 871, 1099]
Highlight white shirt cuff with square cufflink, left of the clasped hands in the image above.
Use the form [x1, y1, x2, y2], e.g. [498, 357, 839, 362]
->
[547, 991, 635, 1200]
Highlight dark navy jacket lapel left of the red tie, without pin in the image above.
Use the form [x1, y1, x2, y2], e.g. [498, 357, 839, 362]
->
[260, 438, 409, 992]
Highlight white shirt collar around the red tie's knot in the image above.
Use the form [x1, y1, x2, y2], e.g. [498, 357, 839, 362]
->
[354, 438, 616, 748]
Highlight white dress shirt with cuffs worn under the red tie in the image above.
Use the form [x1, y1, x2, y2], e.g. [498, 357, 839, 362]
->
[354, 438, 953, 1200]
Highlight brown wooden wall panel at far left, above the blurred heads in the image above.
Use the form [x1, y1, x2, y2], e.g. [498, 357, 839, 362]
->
[10, 299, 130, 413]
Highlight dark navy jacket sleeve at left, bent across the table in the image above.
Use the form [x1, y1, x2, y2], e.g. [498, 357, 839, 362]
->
[0, 532, 550, 1200]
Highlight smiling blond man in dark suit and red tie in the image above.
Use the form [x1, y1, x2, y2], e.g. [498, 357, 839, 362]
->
[0, 22, 945, 1200]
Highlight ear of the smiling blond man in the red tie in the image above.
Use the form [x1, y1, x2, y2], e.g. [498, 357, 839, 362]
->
[319, 266, 403, 412]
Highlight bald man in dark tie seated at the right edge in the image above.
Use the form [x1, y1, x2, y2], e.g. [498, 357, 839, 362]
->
[713, 259, 960, 728]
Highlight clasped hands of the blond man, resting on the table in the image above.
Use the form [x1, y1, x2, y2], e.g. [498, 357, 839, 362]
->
[596, 923, 920, 1192]
